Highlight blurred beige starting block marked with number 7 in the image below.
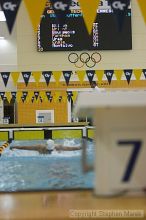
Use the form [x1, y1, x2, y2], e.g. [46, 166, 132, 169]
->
[74, 90, 146, 196]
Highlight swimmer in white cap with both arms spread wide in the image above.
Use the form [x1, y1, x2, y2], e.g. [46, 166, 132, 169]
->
[10, 139, 82, 154]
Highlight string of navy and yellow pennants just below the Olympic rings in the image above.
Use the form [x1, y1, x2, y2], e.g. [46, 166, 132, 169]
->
[0, 68, 146, 87]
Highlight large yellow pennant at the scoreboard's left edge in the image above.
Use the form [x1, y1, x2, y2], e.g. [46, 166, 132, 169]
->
[24, 0, 47, 32]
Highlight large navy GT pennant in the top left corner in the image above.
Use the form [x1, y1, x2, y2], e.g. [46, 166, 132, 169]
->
[0, 0, 21, 33]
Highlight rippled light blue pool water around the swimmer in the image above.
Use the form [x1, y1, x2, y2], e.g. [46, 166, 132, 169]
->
[0, 139, 94, 192]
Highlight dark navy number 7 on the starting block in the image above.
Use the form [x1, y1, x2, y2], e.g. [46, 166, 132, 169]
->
[118, 140, 142, 182]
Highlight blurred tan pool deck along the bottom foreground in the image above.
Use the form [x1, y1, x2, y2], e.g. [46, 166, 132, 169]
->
[0, 190, 146, 220]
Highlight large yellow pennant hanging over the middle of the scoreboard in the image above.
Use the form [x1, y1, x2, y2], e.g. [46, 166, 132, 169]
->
[78, 0, 100, 34]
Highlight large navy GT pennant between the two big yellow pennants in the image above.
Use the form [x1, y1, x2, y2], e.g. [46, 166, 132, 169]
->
[50, 0, 72, 26]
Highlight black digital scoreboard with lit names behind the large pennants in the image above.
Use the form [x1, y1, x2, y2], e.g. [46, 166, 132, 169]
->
[37, 0, 132, 52]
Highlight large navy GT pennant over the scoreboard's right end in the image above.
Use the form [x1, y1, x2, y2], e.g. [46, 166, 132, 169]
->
[108, 0, 130, 31]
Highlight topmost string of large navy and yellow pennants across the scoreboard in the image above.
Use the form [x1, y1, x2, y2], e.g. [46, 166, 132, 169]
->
[0, 0, 146, 34]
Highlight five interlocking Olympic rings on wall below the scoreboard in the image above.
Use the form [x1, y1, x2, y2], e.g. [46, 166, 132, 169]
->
[68, 52, 101, 68]
